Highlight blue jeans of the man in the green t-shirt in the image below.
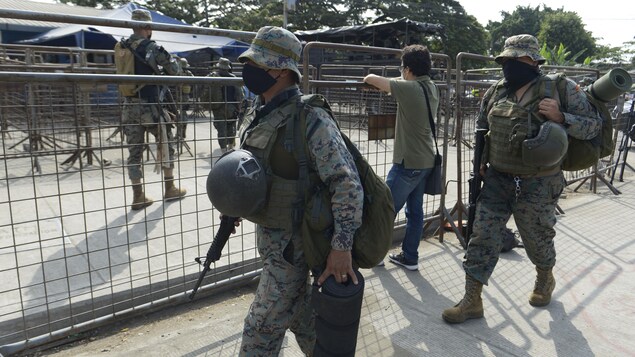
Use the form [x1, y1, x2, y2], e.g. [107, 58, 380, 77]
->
[386, 164, 433, 261]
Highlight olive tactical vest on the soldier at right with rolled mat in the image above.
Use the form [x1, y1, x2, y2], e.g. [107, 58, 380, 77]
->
[487, 76, 558, 175]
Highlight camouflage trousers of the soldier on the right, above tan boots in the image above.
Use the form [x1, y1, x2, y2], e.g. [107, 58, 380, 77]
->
[463, 168, 565, 284]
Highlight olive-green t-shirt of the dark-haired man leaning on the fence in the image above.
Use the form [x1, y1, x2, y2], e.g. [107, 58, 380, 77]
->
[390, 76, 439, 169]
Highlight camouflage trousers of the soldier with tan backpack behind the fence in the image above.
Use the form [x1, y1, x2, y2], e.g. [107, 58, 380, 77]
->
[123, 103, 175, 180]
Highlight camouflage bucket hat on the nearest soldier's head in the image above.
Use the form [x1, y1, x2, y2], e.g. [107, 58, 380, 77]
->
[238, 26, 302, 78]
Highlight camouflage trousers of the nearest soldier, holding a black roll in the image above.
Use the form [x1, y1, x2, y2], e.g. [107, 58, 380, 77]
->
[240, 226, 315, 356]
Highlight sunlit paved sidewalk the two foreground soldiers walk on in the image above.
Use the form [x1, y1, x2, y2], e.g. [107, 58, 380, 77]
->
[14, 159, 635, 357]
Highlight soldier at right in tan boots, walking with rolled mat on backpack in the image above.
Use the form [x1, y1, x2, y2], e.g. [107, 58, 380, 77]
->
[442, 35, 602, 323]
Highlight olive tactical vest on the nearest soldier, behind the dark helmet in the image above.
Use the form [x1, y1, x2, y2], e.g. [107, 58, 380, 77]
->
[241, 97, 320, 230]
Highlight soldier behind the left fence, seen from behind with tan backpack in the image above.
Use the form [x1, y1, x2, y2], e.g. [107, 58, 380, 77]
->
[116, 9, 185, 210]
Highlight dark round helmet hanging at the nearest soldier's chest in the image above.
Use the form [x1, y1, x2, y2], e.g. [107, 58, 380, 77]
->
[207, 149, 267, 217]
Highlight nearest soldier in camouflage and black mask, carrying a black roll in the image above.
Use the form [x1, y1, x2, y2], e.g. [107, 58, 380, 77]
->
[239, 26, 363, 356]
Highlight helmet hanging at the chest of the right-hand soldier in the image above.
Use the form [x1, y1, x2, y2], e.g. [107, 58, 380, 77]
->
[522, 120, 569, 168]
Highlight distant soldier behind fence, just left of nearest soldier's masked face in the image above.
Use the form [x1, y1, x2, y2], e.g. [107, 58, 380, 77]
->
[205, 57, 243, 152]
